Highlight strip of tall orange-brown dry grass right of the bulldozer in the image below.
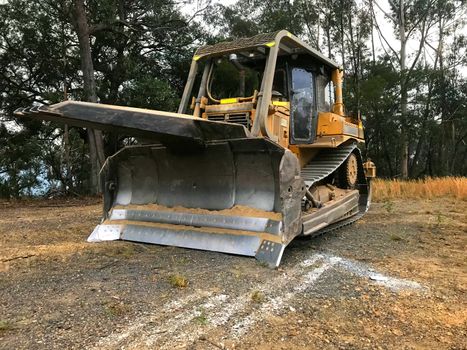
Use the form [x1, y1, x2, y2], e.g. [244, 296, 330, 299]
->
[372, 177, 467, 201]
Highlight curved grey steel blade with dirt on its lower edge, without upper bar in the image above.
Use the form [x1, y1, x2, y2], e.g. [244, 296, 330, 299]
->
[88, 138, 305, 267]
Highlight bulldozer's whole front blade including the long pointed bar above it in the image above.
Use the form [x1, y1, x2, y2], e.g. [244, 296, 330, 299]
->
[16, 101, 306, 266]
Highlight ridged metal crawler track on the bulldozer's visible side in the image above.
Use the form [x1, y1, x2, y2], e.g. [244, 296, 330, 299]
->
[302, 144, 371, 236]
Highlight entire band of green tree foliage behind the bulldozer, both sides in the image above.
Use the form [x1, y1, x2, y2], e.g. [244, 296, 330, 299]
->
[0, 0, 467, 197]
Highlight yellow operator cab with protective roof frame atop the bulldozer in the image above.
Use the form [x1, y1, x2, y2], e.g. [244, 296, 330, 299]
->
[179, 31, 363, 147]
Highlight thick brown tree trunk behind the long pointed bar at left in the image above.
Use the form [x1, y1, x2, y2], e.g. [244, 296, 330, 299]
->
[74, 0, 105, 194]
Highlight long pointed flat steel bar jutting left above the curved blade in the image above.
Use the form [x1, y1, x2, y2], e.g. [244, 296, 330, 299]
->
[15, 101, 248, 146]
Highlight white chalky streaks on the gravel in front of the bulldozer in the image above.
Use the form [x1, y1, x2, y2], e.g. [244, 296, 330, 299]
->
[89, 253, 425, 350]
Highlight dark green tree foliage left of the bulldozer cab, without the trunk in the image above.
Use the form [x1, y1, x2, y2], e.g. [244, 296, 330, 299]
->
[0, 0, 204, 197]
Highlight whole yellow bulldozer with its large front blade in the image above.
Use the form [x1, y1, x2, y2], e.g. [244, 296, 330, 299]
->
[15, 30, 376, 267]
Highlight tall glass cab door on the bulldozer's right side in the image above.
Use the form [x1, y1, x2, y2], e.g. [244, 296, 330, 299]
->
[290, 67, 317, 145]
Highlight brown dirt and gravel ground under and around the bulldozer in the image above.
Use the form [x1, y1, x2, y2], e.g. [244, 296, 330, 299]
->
[0, 199, 467, 349]
